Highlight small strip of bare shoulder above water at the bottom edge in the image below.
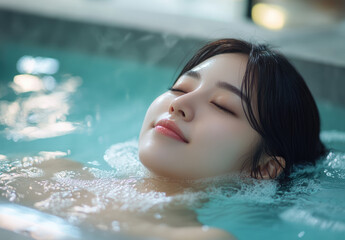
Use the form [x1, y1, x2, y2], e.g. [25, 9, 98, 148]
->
[171, 226, 236, 240]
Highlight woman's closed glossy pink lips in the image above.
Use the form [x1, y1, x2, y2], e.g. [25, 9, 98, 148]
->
[155, 119, 188, 143]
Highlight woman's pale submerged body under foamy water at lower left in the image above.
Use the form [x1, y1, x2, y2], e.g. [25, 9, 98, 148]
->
[0, 155, 235, 239]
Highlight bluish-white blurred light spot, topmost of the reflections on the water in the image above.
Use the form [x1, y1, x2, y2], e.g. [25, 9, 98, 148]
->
[17, 56, 60, 75]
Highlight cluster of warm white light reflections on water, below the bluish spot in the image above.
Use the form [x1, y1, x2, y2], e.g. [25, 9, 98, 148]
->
[0, 74, 82, 141]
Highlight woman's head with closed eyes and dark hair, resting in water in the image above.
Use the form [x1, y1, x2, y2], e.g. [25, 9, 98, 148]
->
[139, 39, 325, 179]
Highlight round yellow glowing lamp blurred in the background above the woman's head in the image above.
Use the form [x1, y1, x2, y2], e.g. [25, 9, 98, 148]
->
[252, 3, 286, 30]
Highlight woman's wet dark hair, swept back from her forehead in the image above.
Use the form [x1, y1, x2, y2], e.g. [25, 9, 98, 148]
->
[174, 39, 326, 179]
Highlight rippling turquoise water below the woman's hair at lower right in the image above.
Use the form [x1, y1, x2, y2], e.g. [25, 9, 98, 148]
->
[196, 150, 345, 239]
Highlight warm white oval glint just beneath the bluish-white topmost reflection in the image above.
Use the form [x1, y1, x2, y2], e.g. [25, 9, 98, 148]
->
[11, 74, 44, 93]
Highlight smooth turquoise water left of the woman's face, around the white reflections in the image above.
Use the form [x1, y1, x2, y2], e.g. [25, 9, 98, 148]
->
[0, 41, 176, 163]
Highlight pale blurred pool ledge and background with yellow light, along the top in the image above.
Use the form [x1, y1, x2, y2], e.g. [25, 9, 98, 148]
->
[0, 0, 345, 71]
